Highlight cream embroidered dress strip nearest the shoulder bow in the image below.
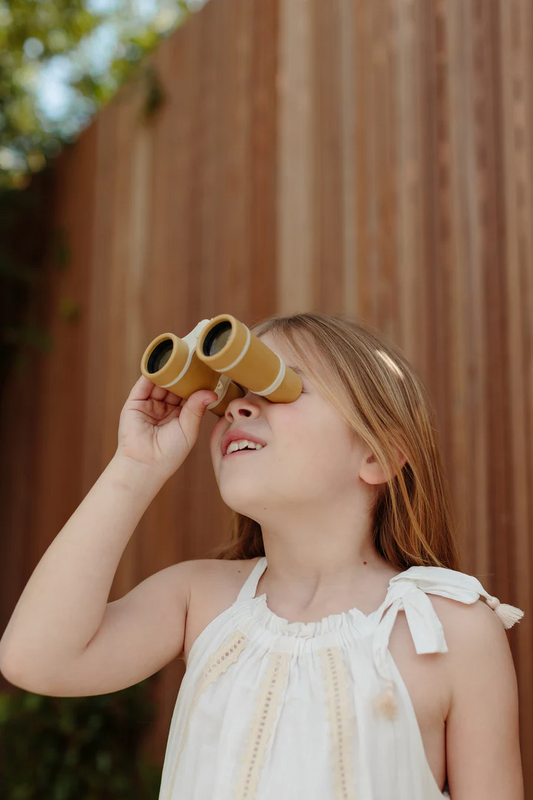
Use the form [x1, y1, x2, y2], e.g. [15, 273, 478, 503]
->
[318, 647, 357, 800]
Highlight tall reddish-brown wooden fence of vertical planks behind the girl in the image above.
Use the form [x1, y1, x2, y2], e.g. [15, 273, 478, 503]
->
[0, 0, 533, 798]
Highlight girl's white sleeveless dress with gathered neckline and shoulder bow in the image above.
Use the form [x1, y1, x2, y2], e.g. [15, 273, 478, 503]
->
[159, 557, 523, 800]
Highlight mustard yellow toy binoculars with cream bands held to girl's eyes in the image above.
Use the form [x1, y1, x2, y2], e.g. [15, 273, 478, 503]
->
[141, 314, 302, 417]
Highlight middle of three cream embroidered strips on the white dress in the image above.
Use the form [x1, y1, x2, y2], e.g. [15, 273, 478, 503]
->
[235, 652, 292, 800]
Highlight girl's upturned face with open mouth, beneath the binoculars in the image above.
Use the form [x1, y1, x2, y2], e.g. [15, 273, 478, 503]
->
[210, 333, 371, 524]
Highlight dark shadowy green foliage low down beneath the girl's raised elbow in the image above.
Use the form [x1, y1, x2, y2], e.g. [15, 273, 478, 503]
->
[0, 679, 161, 800]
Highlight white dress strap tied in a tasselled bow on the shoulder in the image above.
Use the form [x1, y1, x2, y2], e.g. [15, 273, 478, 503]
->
[372, 567, 524, 718]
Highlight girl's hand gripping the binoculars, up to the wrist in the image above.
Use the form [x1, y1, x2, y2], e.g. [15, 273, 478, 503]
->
[115, 375, 217, 477]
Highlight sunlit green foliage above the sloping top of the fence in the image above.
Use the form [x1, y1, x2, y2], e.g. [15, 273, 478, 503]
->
[0, 0, 191, 189]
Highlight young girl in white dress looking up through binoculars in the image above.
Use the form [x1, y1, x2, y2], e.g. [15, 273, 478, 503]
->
[0, 313, 523, 800]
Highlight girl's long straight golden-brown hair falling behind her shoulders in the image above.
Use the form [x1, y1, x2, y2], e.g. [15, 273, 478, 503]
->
[211, 312, 459, 569]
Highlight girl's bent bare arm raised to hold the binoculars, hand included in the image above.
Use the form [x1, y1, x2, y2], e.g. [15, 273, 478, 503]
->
[0, 376, 216, 694]
